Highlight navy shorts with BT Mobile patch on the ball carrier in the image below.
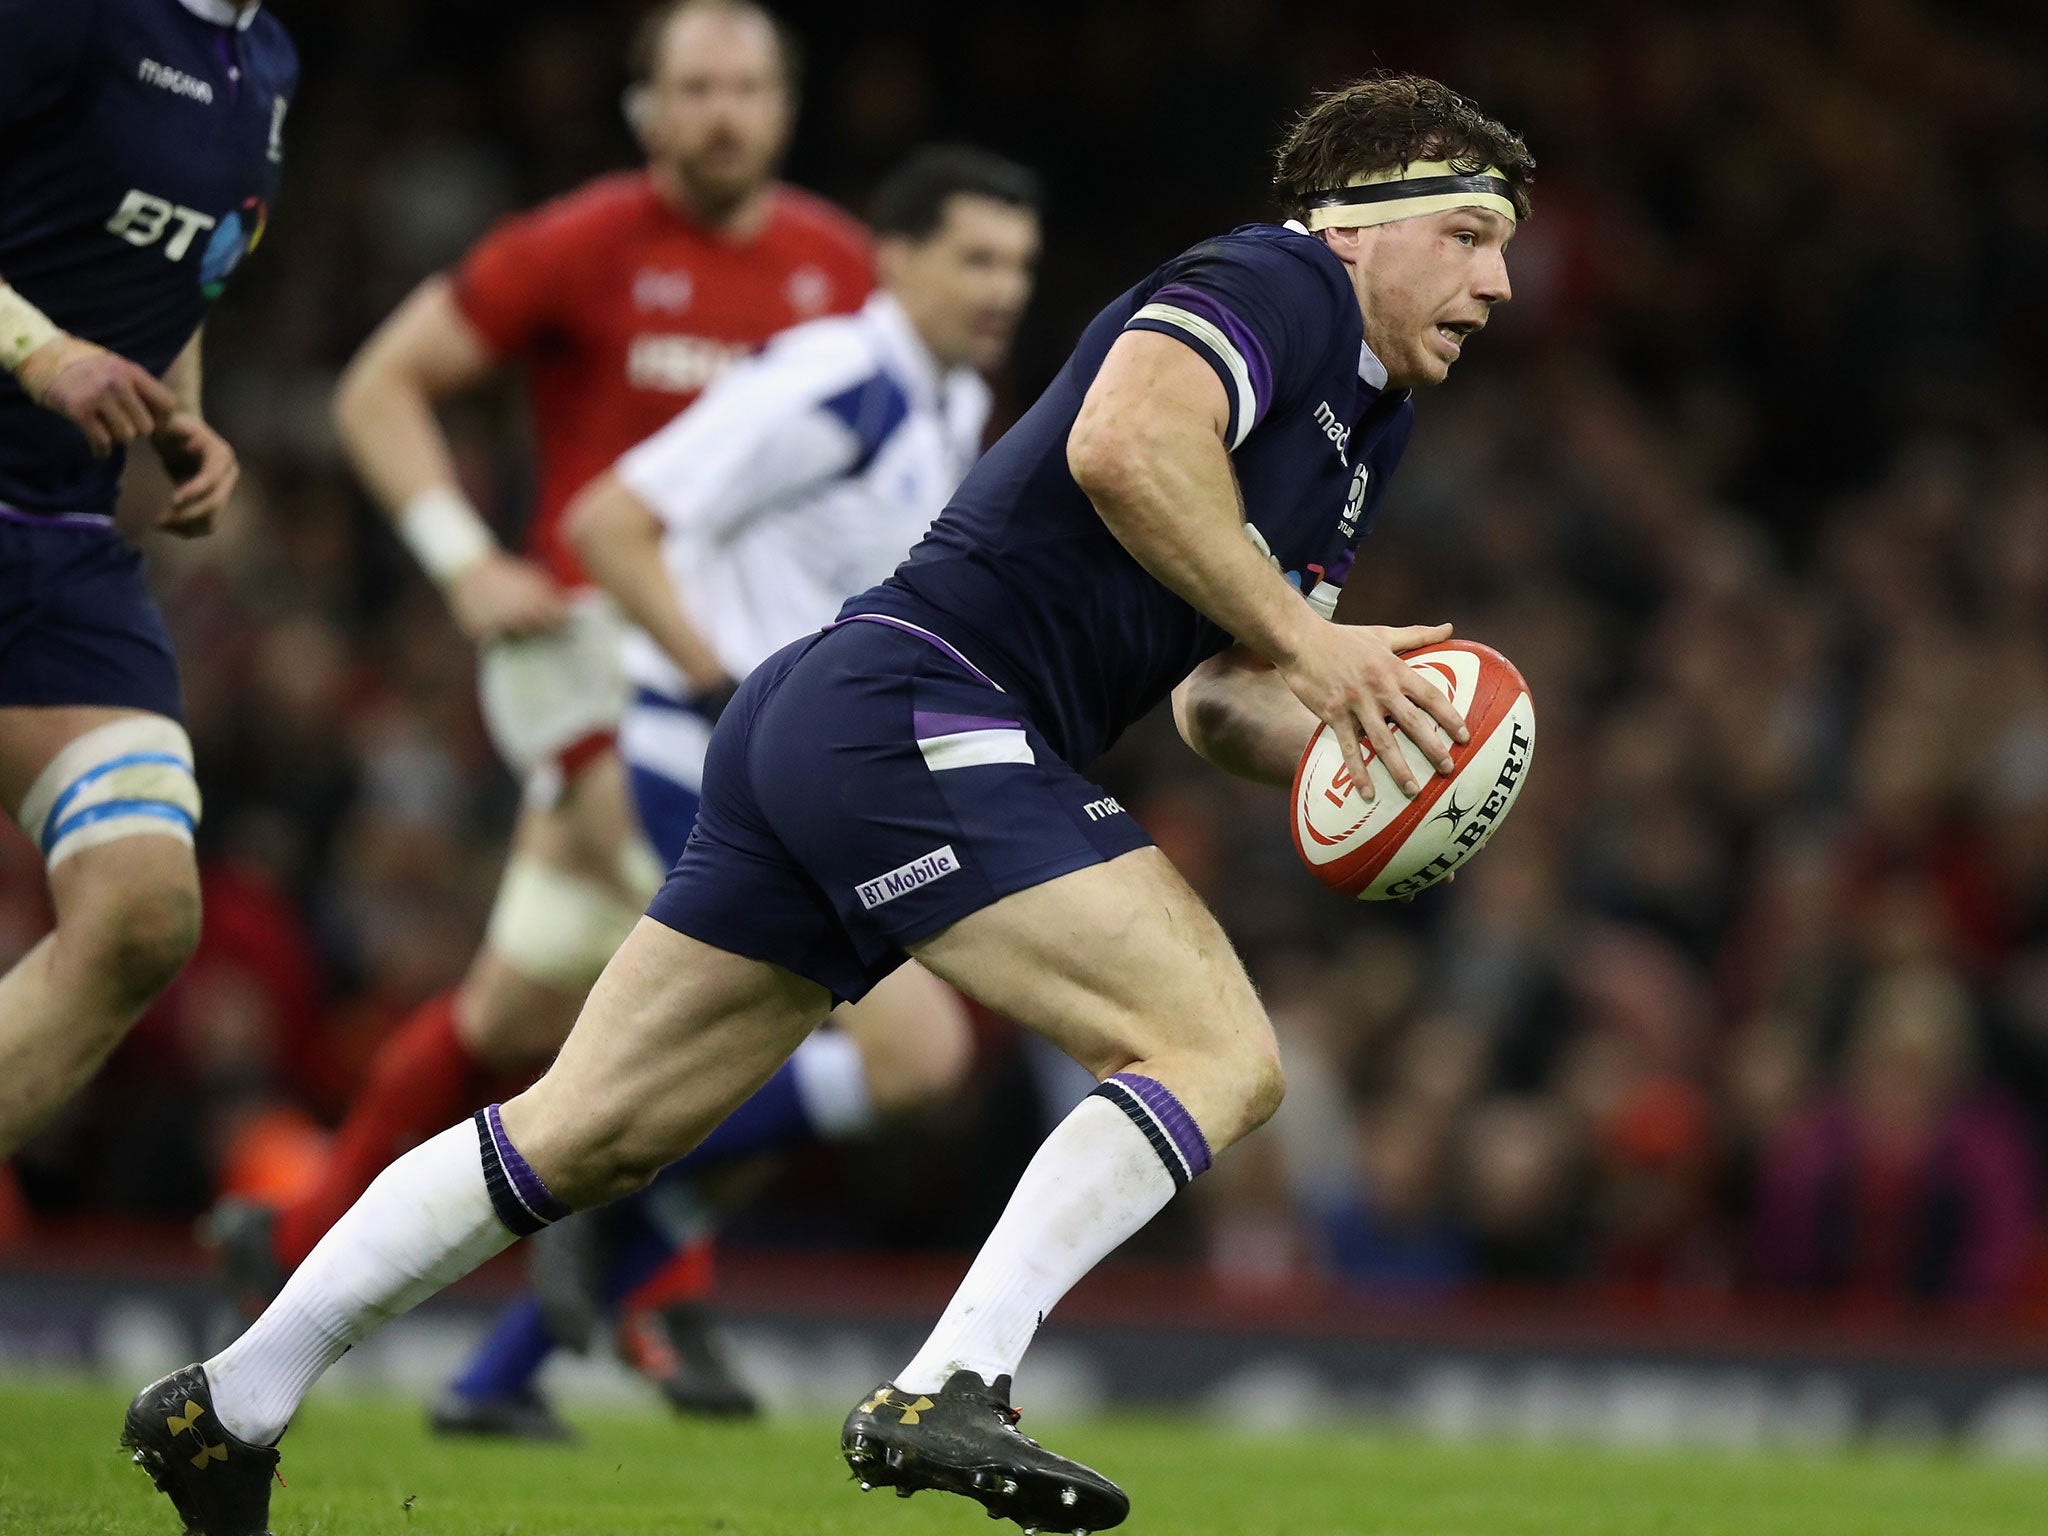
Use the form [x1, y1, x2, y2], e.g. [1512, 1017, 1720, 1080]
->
[647, 621, 1151, 1001]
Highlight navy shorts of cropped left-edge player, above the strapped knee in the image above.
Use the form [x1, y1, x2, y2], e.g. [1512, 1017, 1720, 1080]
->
[0, 508, 184, 719]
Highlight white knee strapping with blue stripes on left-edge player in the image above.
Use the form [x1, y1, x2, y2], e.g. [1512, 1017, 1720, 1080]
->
[20, 715, 199, 868]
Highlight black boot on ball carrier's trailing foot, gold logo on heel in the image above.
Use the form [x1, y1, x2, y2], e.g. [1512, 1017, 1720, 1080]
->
[121, 1366, 276, 1536]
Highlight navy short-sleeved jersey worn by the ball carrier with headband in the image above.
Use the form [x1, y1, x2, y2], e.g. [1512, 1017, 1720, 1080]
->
[844, 223, 1413, 768]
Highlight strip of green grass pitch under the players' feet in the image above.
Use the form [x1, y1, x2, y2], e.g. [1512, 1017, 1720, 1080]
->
[0, 1382, 2048, 1536]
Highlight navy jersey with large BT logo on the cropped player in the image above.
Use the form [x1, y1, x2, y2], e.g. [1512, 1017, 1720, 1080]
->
[0, 0, 299, 512]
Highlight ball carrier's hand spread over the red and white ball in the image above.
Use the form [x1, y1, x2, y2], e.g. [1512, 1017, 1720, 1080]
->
[1280, 625, 1470, 801]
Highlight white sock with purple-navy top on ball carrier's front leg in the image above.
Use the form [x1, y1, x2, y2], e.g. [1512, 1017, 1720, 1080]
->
[895, 1073, 1208, 1393]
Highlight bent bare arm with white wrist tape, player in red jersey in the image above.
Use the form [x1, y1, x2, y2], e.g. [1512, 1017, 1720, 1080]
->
[334, 276, 567, 641]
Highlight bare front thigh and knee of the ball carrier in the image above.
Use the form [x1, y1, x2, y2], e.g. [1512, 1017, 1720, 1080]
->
[911, 848, 1272, 1124]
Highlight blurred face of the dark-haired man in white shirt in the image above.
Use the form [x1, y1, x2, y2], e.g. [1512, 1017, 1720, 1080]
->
[877, 195, 1038, 369]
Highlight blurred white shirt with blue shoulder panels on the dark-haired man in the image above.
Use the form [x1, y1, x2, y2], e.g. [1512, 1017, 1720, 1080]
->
[618, 293, 989, 698]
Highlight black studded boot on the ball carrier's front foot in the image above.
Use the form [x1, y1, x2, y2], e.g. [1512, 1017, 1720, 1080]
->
[840, 1370, 1130, 1536]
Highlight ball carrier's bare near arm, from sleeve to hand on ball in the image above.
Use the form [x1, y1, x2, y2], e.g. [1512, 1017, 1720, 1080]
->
[1067, 332, 1464, 795]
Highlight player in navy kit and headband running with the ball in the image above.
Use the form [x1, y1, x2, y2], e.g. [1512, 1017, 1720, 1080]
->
[129, 76, 1534, 1534]
